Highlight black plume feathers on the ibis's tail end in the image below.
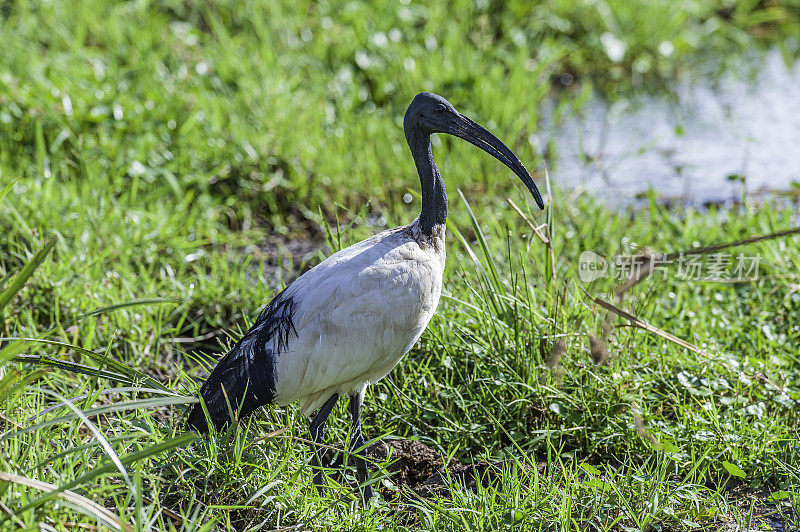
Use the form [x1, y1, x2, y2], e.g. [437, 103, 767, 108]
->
[186, 292, 297, 433]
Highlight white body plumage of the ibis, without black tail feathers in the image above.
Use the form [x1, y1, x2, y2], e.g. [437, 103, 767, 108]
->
[260, 220, 445, 415]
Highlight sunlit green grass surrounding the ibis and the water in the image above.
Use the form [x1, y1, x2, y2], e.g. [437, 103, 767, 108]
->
[0, 0, 800, 530]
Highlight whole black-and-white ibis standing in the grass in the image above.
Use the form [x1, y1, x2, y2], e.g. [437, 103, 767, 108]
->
[188, 93, 544, 500]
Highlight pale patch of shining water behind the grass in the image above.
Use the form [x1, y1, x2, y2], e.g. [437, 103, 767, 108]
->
[550, 52, 800, 204]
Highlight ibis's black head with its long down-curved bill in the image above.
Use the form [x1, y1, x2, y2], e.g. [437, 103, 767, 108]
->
[403, 92, 544, 209]
